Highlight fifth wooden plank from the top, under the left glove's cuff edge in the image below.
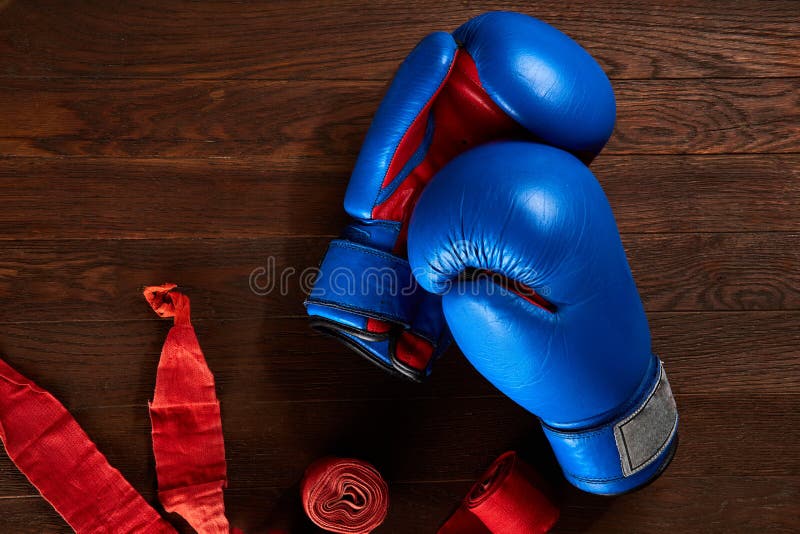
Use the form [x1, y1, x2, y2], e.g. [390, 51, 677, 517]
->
[0, 314, 800, 409]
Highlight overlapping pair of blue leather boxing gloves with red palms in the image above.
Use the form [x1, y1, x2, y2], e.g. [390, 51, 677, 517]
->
[306, 13, 678, 494]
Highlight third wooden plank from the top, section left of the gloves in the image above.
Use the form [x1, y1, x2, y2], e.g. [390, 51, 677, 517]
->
[0, 158, 354, 240]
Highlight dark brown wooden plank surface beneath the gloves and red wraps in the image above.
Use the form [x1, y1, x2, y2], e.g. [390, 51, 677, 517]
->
[0, 0, 800, 534]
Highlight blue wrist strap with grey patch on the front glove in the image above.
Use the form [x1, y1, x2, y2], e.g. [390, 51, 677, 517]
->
[543, 357, 678, 494]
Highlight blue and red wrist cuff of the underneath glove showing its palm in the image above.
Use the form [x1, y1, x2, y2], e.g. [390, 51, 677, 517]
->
[305, 238, 449, 381]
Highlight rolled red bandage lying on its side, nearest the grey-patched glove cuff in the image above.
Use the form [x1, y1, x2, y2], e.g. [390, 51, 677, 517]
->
[438, 452, 559, 534]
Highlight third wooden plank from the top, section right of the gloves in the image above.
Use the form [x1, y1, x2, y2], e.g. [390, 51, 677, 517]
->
[592, 154, 800, 233]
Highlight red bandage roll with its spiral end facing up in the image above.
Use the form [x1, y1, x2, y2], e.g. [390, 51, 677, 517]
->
[300, 458, 389, 534]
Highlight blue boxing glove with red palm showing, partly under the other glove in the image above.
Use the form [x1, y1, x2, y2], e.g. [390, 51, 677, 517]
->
[306, 12, 615, 380]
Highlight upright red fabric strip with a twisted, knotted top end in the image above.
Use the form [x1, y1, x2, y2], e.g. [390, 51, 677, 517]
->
[144, 284, 230, 534]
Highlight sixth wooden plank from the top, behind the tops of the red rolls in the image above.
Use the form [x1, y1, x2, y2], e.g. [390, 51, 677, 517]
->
[0, 392, 800, 497]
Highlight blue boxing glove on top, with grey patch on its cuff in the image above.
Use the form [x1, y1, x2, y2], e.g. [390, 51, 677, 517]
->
[408, 142, 678, 494]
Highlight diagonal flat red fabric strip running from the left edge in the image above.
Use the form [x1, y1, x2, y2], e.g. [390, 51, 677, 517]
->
[0, 360, 175, 533]
